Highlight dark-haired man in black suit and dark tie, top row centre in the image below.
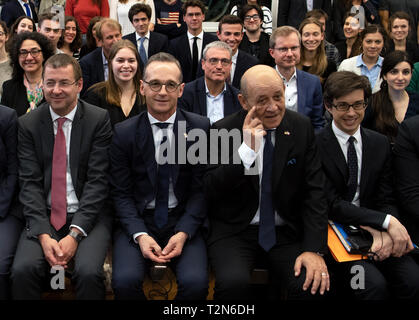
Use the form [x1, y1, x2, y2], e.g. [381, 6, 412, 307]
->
[169, 0, 217, 83]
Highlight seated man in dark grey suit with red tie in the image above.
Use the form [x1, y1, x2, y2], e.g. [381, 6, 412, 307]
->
[11, 53, 112, 300]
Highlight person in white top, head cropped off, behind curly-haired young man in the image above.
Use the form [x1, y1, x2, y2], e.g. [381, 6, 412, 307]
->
[109, 0, 156, 36]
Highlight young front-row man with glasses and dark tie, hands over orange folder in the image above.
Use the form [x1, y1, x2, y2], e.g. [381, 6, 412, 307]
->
[317, 71, 419, 300]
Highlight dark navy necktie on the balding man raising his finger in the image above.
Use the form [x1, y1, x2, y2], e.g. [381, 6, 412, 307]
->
[259, 130, 276, 251]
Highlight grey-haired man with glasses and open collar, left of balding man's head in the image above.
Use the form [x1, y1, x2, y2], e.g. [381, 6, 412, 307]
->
[179, 41, 241, 123]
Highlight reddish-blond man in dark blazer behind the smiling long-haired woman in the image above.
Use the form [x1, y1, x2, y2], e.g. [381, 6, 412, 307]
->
[80, 18, 124, 97]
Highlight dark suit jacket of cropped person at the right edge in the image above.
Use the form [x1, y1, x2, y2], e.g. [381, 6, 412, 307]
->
[394, 116, 419, 244]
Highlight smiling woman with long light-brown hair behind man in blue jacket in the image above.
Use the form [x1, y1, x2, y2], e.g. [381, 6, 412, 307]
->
[297, 18, 336, 84]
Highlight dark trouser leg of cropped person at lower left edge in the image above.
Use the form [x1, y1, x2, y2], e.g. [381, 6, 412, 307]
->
[0, 214, 23, 300]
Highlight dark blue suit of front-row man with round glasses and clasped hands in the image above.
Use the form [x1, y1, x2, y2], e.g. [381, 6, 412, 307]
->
[110, 109, 210, 300]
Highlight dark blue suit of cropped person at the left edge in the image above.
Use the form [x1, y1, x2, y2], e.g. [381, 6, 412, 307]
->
[0, 106, 22, 300]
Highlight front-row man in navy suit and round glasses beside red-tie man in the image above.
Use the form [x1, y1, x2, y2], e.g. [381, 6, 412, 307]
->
[109, 53, 210, 300]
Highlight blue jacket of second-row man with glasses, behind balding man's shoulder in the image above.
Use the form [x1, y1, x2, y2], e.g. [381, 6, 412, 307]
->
[297, 69, 324, 131]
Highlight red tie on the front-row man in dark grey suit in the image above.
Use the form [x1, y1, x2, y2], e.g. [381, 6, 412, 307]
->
[51, 118, 67, 231]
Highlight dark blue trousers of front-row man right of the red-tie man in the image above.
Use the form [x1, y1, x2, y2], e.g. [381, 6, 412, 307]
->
[112, 211, 208, 300]
